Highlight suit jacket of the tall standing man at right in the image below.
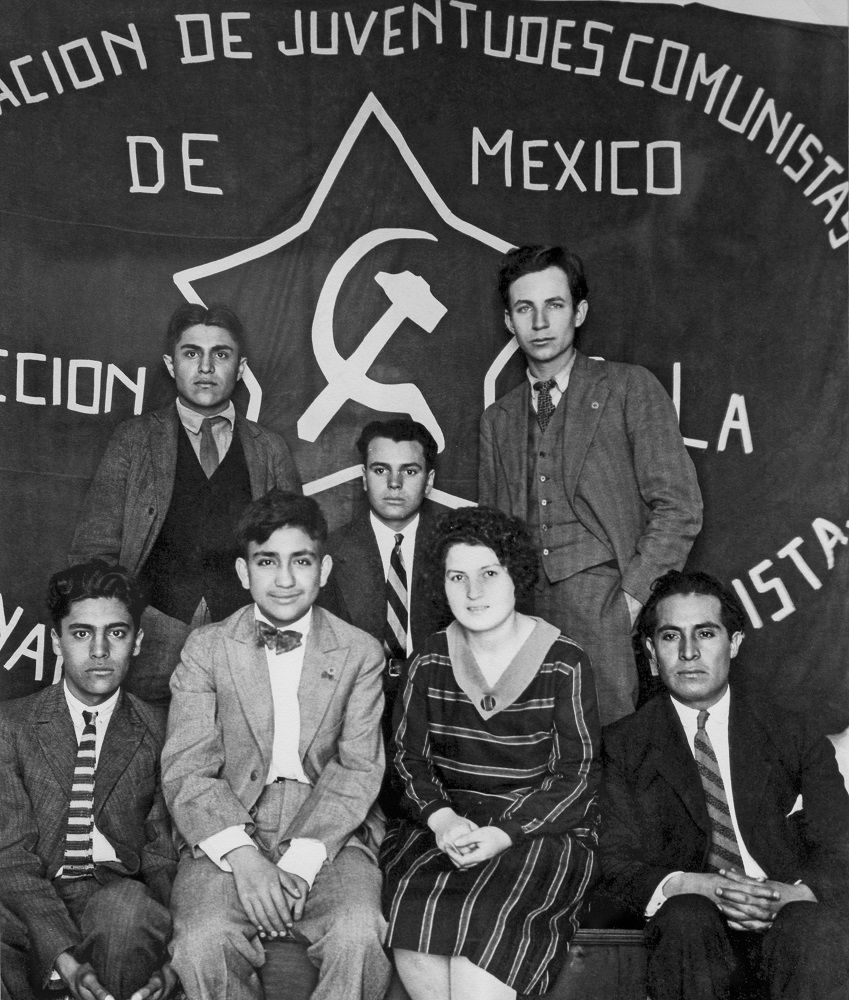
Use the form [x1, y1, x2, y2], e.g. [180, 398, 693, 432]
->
[478, 352, 702, 603]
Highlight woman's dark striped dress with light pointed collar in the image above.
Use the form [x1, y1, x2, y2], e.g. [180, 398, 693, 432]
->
[381, 621, 599, 994]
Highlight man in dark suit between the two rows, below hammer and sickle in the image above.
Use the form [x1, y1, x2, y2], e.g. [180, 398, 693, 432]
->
[318, 419, 444, 815]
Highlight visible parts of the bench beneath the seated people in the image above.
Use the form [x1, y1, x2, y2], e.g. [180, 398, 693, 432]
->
[262, 927, 646, 1000]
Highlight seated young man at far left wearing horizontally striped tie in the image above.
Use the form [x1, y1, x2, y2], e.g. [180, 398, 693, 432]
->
[0, 560, 176, 1000]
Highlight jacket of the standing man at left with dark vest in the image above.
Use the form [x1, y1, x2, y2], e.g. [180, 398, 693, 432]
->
[68, 403, 301, 573]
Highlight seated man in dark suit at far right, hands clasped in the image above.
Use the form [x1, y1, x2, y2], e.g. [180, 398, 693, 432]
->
[600, 570, 849, 1000]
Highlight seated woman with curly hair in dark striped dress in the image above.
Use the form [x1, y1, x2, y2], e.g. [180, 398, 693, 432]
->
[381, 508, 599, 1000]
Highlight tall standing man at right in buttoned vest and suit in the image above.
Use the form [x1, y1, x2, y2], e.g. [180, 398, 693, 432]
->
[478, 246, 702, 723]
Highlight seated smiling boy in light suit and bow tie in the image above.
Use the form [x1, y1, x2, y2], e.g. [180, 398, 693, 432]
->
[162, 490, 391, 1000]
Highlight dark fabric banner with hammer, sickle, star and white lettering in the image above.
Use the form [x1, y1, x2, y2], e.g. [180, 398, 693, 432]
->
[0, 0, 849, 731]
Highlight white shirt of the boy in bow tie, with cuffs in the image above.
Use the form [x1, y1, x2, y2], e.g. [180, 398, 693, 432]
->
[198, 605, 327, 888]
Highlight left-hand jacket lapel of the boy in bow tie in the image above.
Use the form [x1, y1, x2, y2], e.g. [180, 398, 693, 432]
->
[224, 604, 274, 769]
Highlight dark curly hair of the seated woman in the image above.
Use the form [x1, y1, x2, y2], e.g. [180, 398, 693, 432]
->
[424, 507, 539, 621]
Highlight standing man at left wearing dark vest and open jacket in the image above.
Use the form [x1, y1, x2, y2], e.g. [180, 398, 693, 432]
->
[70, 303, 300, 704]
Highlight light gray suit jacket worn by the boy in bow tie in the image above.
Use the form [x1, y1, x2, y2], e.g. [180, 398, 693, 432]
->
[162, 604, 384, 861]
